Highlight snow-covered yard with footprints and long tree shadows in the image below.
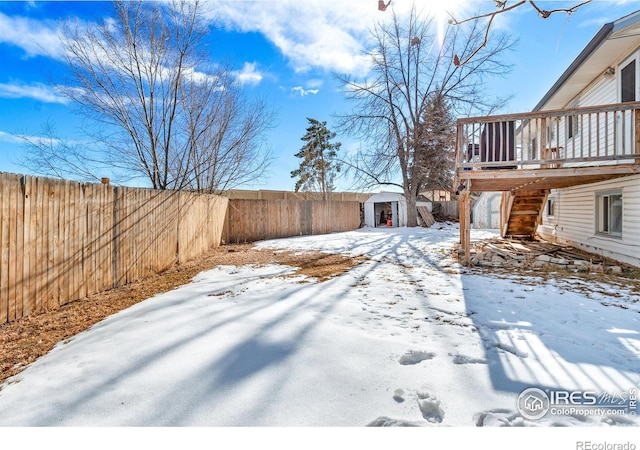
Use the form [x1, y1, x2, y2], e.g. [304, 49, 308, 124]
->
[0, 224, 640, 442]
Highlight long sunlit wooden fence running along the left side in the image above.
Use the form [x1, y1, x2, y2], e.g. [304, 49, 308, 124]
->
[0, 173, 228, 324]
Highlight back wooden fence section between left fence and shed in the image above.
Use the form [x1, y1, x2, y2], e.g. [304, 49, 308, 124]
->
[223, 199, 360, 243]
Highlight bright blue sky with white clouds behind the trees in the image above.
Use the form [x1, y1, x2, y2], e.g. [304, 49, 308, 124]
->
[0, 0, 640, 190]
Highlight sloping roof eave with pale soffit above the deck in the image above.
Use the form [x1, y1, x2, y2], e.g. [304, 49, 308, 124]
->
[533, 11, 640, 111]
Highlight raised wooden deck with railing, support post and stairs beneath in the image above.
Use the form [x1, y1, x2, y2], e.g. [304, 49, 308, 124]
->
[454, 102, 640, 263]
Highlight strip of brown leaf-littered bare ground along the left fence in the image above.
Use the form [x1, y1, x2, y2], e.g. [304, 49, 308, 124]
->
[0, 244, 363, 389]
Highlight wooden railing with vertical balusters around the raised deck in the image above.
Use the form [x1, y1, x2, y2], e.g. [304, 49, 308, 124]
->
[456, 102, 640, 170]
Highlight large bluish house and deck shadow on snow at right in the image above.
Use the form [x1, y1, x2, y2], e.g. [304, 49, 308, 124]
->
[459, 275, 640, 402]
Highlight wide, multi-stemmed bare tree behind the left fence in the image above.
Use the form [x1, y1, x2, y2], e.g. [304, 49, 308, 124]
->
[21, 1, 274, 192]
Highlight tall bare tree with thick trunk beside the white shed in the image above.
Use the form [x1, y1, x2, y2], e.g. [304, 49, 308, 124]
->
[338, 4, 513, 226]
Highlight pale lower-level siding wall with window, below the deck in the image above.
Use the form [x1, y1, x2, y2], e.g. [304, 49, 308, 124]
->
[538, 176, 640, 267]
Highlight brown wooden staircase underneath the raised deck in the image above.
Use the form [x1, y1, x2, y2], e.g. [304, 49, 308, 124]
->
[500, 189, 549, 238]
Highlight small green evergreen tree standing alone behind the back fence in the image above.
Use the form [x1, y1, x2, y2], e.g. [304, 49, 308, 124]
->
[291, 117, 342, 199]
